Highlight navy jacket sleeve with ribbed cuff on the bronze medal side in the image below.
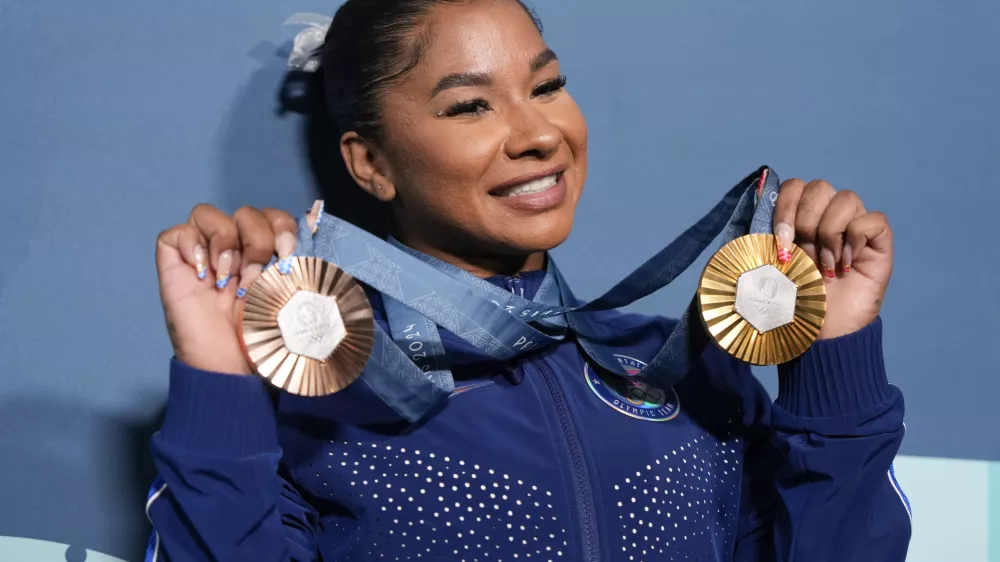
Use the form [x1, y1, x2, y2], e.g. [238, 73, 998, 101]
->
[146, 360, 319, 562]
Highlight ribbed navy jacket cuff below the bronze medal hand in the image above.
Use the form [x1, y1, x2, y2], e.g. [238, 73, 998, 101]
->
[160, 358, 280, 457]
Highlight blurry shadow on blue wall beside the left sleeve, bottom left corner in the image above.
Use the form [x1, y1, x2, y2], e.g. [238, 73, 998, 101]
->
[0, 396, 162, 562]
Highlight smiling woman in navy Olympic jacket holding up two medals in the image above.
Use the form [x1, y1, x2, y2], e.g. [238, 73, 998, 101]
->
[147, 0, 910, 562]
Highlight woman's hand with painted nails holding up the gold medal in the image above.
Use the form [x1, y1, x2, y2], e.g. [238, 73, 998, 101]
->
[774, 179, 892, 339]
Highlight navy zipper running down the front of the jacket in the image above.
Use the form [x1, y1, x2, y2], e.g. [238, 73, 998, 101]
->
[530, 358, 600, 562]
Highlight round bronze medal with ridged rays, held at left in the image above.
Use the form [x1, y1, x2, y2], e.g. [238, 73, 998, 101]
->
[238, 257, 375, 396]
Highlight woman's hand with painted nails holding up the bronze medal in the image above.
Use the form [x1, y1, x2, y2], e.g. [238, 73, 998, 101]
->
[156, 202, 319, 374]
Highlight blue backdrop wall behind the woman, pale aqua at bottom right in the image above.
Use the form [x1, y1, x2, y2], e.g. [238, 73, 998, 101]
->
[0, 0, 1000, 562]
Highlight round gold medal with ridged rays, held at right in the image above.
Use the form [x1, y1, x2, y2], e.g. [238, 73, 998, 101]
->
[698, 234, 826, 365]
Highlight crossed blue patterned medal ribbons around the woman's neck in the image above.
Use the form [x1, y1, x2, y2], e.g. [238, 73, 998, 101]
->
[296, 167, 778, 421]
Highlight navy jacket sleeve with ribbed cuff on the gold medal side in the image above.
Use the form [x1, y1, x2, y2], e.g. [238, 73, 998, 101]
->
[734, 319, 911, 562]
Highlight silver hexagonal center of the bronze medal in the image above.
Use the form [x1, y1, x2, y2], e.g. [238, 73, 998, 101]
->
[278, 291, 347, 361]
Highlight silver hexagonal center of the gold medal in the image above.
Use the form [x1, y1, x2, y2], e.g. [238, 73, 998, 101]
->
[736, 265, 798, 332]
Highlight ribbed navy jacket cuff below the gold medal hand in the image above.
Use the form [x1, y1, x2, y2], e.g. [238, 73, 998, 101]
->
[775, 318, 892, 418]
